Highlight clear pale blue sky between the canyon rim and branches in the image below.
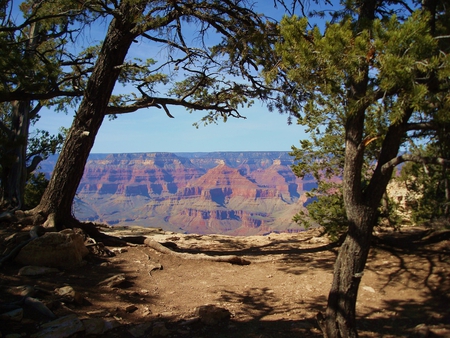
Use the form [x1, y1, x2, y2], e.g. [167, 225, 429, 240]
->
[29, 1, 330, 153]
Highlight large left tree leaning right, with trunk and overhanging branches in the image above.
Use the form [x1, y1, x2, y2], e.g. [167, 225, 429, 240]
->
[29, 0, 272, 229]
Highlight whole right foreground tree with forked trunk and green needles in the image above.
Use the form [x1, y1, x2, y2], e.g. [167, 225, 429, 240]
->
[261, 0, 450, 337]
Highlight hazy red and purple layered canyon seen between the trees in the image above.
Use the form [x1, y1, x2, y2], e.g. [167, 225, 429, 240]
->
[41, 152, 315, 236]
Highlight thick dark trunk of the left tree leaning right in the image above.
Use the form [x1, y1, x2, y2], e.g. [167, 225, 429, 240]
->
[33, 1, 145, 229]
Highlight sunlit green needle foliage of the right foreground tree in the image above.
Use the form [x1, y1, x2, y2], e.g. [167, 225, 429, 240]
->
[263, 2, 450, 235]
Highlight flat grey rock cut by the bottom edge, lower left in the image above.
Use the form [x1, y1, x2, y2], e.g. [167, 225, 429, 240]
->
[31, 314, 84, 338]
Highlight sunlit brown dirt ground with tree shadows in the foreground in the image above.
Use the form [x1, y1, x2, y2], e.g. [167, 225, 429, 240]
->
[0, 224, 450, 338]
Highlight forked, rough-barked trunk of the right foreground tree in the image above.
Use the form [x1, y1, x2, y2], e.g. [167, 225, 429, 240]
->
[318, 110, 412, 338]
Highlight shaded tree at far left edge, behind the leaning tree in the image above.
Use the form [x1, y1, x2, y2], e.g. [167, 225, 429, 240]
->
[0, 1, 89, 209]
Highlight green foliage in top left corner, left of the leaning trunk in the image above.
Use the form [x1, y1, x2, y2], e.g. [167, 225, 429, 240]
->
[0, 0, 90, 99]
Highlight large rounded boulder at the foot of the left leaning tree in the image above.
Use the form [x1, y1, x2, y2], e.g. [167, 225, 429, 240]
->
[15, 229, 89, 268]
